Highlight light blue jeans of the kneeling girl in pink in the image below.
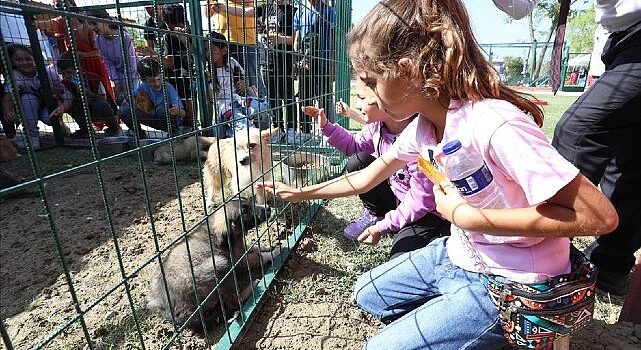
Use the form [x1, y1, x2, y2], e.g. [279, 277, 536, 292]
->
[354, 238, 508, 350]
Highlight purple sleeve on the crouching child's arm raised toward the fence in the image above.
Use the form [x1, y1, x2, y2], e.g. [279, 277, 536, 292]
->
[322, 122, 374, 156]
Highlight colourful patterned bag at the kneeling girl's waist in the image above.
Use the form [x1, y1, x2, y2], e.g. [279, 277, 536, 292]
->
[485, 247, 597, 349]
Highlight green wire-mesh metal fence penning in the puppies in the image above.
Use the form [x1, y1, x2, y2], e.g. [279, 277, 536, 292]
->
[0, 0, 351, 349]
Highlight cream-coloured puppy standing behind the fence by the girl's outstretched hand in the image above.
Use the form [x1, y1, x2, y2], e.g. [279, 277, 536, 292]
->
[203, 128, 272, 207]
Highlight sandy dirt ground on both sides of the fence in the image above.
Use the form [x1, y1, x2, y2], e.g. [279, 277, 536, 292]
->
[0, 149, 641, 349]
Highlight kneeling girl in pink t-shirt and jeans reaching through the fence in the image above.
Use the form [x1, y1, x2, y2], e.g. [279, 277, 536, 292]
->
[260, 0, 618, 349]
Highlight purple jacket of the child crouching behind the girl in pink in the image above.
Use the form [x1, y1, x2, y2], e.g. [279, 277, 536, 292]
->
[322, 122, 440, 233]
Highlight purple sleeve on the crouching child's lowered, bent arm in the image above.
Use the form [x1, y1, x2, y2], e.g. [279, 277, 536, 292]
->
[376, 163, 438, 234]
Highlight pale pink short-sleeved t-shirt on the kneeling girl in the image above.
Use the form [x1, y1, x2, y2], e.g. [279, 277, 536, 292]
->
[389, 99, 579, 283]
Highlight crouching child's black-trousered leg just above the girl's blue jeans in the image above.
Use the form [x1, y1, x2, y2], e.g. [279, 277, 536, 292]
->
[390, 213, 451, 260]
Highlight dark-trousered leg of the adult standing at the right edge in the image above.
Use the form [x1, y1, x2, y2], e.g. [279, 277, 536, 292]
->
[552, 24, 641, 274]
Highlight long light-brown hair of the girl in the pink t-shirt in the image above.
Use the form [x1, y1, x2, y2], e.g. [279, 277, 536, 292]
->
[348, 0, 543, 126]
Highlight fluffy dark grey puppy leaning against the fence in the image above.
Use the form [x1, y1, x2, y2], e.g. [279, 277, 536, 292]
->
[147, 199, 280, 332]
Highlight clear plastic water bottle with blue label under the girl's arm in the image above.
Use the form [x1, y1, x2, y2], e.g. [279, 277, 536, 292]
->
[443, 140, 508, 209]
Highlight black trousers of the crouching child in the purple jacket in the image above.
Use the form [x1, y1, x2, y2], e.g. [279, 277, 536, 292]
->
[347, 152, 450, 260]
